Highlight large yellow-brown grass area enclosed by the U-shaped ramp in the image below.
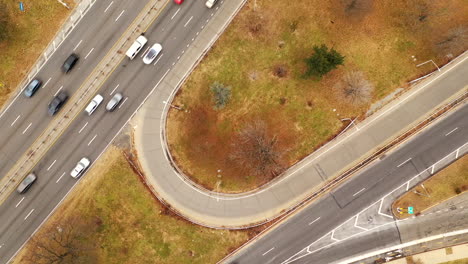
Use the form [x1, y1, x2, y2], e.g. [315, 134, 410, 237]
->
[167, 0, 468, 192]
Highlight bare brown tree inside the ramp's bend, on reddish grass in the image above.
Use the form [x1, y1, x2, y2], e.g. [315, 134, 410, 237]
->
[230, 120, 286, 177]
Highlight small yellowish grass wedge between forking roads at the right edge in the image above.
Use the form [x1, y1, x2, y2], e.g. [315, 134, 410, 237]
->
[393, 155, 468, 218]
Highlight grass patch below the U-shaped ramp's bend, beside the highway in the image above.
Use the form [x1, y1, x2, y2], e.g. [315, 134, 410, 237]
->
[14, 148, 249, 264]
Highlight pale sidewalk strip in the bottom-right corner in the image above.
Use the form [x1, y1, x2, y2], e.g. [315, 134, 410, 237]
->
[387, 244, 468, 264]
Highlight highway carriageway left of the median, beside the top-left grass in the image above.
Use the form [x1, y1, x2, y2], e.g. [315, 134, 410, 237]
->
[0, 0, 147, 177]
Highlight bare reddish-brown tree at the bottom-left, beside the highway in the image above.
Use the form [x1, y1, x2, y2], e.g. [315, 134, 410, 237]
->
[22, 218, 94, 264]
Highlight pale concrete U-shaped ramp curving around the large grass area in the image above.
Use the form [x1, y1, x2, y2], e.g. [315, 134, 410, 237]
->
[135, 0, 468, 228]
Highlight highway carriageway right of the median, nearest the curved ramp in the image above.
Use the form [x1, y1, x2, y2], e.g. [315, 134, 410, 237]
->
[0, 1, 224, 263]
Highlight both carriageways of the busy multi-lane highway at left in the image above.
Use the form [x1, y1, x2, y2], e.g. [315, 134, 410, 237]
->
[0, 0, 222, 263]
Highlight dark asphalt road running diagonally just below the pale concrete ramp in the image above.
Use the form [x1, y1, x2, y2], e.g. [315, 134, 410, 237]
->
[228, 102, 468, 264]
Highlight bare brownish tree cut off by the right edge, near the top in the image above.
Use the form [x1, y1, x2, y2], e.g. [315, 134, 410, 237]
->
[436, 26, 468, 55]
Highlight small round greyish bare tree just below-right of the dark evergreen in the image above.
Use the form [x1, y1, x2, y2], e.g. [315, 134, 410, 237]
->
[335, 71, 374, 105]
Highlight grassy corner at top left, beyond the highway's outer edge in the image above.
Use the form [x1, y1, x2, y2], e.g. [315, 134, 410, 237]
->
[0, 0, 74, 107]
